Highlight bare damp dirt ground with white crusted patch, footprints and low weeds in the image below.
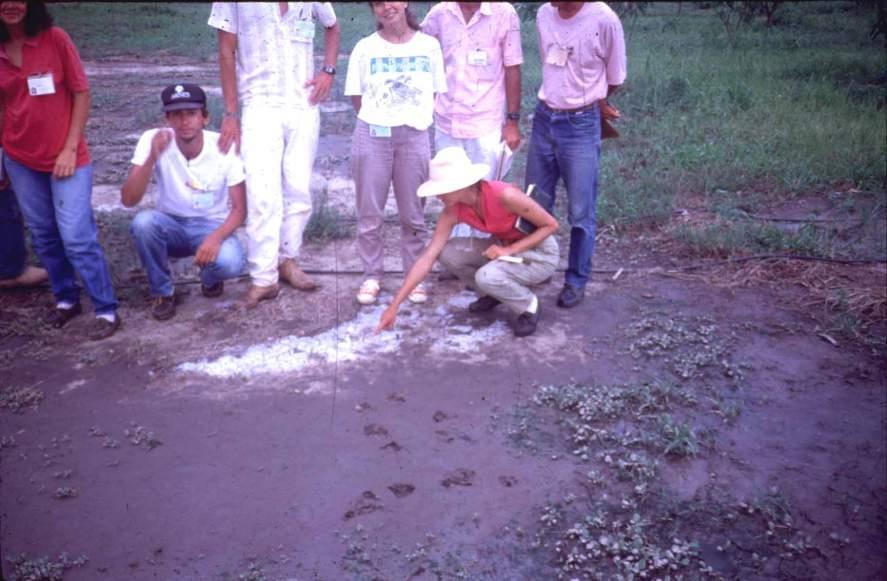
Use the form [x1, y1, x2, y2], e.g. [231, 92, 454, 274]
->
[0, 60, 887, 580]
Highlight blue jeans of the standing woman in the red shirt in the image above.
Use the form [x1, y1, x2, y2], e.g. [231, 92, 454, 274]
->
[4, 157, 117, 315]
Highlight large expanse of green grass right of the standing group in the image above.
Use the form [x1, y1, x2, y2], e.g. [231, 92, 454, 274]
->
[602, 3, 887, 215]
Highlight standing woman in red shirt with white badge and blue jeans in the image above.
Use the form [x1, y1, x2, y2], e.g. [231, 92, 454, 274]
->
[0, 0, 120, 339]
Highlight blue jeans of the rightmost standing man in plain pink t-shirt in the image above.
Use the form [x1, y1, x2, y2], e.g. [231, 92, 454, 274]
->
[526, 102, 601, 288]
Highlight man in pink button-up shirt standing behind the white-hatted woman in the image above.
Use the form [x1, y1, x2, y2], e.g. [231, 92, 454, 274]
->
[422, 2, 523, 237]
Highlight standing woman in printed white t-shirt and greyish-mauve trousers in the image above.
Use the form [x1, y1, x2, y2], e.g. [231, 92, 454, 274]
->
[345, 2, 447, 305]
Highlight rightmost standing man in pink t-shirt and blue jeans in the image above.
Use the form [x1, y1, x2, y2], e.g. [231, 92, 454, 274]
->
[526, 2, 626, 308]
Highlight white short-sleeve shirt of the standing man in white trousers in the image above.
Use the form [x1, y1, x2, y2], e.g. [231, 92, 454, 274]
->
[209, 2, 336, 108]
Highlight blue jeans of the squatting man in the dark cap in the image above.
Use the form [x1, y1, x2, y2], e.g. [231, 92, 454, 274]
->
[129, 210, 246, 297]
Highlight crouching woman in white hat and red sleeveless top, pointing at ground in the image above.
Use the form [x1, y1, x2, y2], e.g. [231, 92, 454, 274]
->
[376, 147, 560, 337]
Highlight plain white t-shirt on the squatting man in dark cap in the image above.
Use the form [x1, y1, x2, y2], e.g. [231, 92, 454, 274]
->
[131, 129, 245, 220]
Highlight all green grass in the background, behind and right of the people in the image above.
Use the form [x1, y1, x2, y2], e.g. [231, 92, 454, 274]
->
[51, 2, 887, 258]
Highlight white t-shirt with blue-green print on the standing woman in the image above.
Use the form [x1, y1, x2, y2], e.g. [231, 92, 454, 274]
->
[345, 32, 447, 130]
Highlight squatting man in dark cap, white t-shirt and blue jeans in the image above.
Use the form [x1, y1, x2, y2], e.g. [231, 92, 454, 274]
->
[121, 83, 246, 321]
